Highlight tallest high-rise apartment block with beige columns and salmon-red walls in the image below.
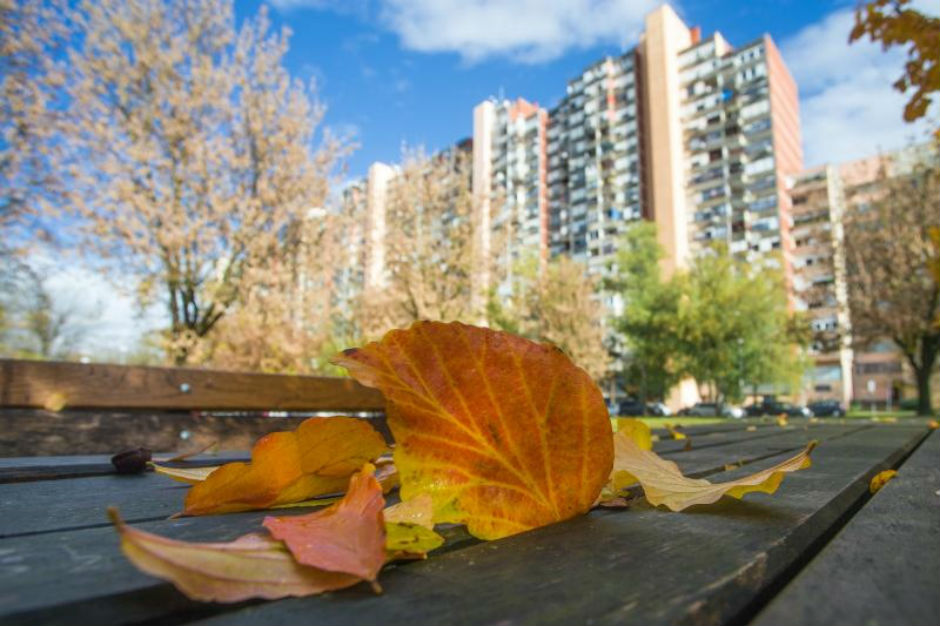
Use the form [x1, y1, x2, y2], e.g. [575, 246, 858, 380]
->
[342, 5, 802, 402]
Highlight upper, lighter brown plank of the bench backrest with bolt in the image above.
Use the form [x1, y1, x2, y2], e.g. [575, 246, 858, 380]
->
[0, 359, 385, 411]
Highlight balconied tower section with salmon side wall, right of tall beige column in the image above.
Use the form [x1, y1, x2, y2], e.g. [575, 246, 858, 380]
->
[679, 33, 803, 270]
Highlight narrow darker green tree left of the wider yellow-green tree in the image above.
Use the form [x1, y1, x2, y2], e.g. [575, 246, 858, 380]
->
[605, 222, 681, 403]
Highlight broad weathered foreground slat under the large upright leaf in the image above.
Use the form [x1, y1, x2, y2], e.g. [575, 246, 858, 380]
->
[178, 427, 924, 626]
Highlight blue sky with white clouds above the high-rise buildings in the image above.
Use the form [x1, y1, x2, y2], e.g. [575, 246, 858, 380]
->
[236, 0, 936, 177]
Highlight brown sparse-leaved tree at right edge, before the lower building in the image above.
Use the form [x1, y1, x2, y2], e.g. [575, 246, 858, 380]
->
[845, 150, 940, 415]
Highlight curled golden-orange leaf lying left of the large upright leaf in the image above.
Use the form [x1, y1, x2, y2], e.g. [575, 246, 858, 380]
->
[183, 417, 386, 515]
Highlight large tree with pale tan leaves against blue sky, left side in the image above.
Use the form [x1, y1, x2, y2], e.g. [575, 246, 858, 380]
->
[49, 0, 343, 364]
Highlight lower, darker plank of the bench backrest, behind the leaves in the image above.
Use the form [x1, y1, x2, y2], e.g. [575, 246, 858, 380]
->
[0, 409, 390, 456]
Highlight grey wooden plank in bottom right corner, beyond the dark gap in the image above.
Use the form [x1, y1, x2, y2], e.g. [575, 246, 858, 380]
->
[752, 432, 940, 626]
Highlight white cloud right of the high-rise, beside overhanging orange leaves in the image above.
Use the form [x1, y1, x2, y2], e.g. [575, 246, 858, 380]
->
[781, 9, 928, 167]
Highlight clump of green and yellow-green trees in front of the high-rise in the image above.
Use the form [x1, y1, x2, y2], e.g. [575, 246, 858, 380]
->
[605, 223, 809, 402]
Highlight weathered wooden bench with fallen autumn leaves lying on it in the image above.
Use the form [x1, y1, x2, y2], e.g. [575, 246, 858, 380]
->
[0, 362, 940, 626]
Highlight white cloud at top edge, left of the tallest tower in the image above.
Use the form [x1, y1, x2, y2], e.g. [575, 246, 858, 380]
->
[381, 0, 660, 63]
